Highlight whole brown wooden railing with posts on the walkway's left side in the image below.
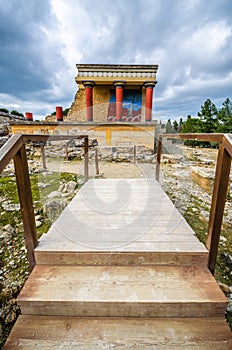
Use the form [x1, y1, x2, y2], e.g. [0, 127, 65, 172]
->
[0, 134, 89, 269]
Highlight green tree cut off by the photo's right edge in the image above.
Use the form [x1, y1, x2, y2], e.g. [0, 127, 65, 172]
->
[217, 98, 232, 133]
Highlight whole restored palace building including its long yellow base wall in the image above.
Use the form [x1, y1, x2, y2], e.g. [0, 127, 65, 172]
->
[12, 64, 158, 147]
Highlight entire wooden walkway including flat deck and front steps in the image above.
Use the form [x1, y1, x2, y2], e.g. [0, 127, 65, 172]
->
[5, 178, 232, 350]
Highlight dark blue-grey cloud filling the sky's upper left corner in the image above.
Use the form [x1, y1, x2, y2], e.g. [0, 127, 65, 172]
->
[0, 0, 68, 99]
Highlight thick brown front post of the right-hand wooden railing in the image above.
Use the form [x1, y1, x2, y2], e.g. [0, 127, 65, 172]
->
[206, 144, 231, 274]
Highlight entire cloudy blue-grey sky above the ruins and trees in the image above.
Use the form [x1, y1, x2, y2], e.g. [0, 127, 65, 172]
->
[0, 0, 232, 119]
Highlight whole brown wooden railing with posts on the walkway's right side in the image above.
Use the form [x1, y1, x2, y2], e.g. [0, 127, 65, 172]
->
[156, 134, 232, 274]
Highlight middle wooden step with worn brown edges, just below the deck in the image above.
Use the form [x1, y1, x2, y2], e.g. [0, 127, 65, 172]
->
[18, 265, 227, 317]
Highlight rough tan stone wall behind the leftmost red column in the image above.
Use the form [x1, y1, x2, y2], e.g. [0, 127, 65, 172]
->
[65, 85, 110, 123]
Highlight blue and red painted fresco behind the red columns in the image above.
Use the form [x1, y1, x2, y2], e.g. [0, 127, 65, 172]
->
[107, 89, 142, 122]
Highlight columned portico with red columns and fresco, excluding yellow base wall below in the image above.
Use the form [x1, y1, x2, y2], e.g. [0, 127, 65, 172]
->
[65, 64, 158, 123]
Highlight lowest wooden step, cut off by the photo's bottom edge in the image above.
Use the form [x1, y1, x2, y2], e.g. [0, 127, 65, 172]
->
[4, 315, 232, 350]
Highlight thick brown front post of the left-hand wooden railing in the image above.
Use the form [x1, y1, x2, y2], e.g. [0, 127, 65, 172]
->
[14, 144, 38, 269]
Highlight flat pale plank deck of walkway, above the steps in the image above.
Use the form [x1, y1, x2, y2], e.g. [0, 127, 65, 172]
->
[36, 179, 207, 261]
